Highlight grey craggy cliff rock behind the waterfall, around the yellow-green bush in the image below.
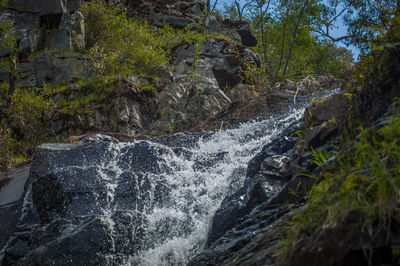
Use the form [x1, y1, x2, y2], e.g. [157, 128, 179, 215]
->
[0, 1, 266, 137]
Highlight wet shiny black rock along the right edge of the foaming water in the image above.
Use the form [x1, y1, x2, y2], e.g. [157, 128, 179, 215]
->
[203, 121, 301, 250]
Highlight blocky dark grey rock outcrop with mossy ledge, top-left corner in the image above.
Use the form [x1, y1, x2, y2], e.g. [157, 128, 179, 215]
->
[0, 0, 85, 87]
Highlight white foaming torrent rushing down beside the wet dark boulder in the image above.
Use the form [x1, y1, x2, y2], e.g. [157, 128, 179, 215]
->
[122, 105, 304, 265]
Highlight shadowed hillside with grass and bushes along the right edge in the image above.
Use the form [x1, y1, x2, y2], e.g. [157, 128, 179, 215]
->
[278, 14, 400, 265]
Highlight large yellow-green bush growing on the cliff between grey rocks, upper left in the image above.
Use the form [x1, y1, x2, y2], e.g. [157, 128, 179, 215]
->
[80, 0, 168, 76]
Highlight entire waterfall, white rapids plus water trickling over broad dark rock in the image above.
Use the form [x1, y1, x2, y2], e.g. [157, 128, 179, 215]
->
[0, 95, 320, 266]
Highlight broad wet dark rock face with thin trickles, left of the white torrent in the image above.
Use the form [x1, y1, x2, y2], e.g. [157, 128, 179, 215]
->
[0, 136, 170, 265]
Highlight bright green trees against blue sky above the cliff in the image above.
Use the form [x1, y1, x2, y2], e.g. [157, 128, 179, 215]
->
[219, 0, 353, 81]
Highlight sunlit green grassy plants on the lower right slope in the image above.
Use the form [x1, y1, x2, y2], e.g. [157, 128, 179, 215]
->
[280, 103, 400, 259]
